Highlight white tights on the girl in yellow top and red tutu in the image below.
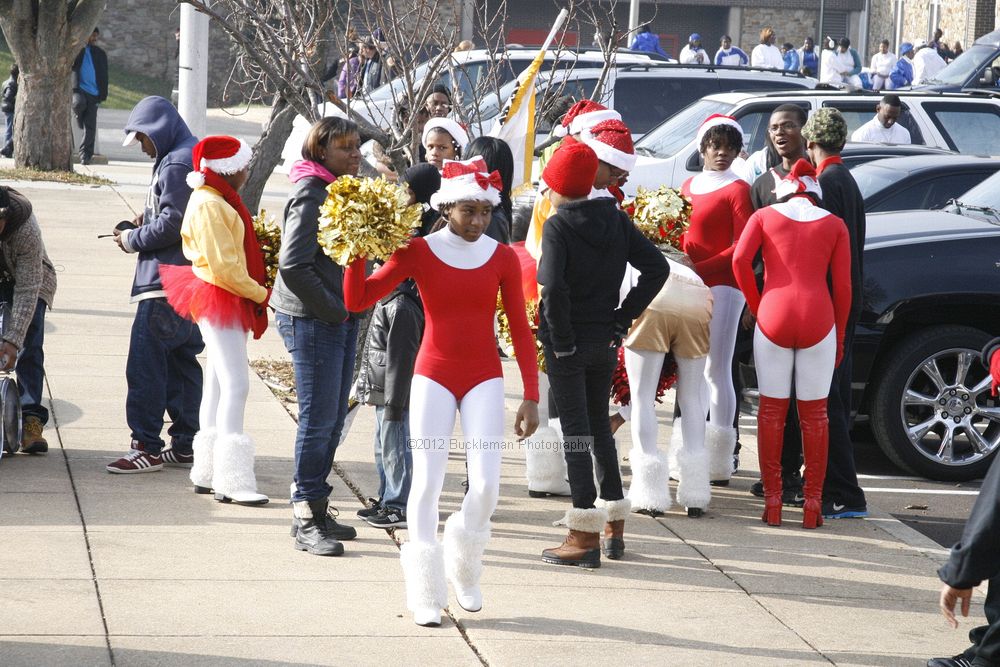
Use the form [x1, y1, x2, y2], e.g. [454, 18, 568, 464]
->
[198, 322, 250, 437]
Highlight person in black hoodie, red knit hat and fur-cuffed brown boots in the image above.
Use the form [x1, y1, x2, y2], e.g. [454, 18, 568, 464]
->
[538, 140, 670, 568]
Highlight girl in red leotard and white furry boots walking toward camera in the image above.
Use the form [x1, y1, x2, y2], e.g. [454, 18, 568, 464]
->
[344, 158, 538, 625]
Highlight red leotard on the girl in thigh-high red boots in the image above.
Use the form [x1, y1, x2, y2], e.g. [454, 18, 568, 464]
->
[733, 197, 851, 349]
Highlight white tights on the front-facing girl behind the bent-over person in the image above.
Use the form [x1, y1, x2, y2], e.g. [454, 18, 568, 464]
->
[704, 285, 746, 428]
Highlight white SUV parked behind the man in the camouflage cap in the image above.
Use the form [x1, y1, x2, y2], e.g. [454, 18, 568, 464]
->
[626, 90, 1000, 194]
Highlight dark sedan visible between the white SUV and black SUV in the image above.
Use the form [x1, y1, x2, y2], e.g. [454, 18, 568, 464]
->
[851, 155, 1000, 213]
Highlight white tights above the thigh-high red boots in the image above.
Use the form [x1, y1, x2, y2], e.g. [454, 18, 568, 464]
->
[752, 327, 837, 400]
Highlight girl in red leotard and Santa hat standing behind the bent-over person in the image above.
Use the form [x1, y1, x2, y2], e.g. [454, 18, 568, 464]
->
[675, 114, 753, 481]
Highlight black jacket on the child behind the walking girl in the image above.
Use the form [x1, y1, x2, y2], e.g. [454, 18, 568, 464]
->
[356, 280, 424, 421]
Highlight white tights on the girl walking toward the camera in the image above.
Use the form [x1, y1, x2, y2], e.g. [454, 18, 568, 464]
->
[406, 375, 504, 544]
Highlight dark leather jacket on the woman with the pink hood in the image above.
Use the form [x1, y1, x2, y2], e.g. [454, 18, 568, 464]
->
[270, 176, 348, 324]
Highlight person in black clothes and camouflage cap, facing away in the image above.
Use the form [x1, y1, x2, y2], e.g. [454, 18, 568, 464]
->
[800, 107, 868, 519]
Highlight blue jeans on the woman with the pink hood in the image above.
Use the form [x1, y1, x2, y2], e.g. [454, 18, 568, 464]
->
[274, 312, 358, 501]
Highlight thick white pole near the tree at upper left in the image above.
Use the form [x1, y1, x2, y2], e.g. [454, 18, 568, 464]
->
[177, 4, 208, 138]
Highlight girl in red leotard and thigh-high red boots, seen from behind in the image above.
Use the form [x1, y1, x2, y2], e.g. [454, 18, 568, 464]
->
[733, 160, 851, 528]
